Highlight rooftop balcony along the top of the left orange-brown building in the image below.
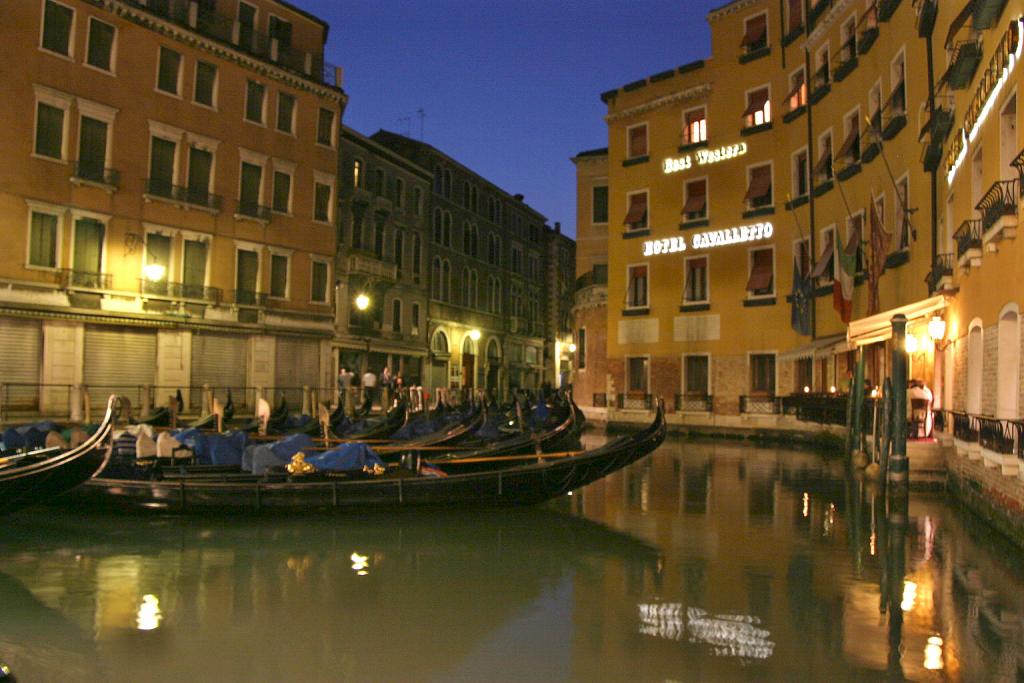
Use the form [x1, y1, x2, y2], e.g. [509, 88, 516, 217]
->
[124, 0, 341, 88]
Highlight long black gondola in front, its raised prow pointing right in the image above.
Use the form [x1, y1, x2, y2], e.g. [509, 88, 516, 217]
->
[60, 400, 666, 513]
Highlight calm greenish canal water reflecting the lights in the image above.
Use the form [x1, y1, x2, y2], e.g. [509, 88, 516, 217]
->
[0, 435, 1024, 683]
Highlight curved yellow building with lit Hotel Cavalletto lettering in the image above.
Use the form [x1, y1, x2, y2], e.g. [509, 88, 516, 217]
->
[574, 0, 1024, 436]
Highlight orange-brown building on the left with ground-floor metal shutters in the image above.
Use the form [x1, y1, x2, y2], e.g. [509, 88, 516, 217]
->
[0, 0, 346, 415]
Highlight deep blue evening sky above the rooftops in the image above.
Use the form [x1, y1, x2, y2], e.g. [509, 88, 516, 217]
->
[303, 0, 738, 236]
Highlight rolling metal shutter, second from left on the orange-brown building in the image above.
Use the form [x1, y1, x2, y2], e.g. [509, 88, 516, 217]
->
[83, 326, 157, 416]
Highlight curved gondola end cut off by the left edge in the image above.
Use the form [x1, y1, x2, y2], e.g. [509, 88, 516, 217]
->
[0, 396, 120, 514]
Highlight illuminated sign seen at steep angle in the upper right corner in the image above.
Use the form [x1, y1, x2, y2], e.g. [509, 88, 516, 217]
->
[946, 18, 1024, 184]
